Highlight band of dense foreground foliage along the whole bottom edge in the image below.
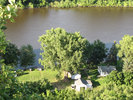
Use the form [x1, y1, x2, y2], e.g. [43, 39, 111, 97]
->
[0, 71, 133, 100]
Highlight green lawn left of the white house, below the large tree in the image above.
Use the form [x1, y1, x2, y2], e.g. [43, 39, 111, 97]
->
[17, 69, 74, 89]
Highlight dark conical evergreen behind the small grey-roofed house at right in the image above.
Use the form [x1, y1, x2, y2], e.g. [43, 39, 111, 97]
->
[106, 41, 118, 65]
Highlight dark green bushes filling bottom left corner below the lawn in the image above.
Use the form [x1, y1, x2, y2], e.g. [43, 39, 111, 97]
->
[0, 66, 53, 100]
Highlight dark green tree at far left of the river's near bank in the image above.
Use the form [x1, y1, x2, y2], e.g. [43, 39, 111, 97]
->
[2, 43, 20, 66]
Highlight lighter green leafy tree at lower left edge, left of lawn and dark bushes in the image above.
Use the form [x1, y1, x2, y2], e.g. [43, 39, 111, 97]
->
[0, 64, 17, 100]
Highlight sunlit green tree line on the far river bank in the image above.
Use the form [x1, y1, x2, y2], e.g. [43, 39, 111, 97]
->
[0, 0, 133, 9]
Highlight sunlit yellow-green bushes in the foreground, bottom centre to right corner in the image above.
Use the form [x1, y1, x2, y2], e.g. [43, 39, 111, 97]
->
[41, 83, 133, 100]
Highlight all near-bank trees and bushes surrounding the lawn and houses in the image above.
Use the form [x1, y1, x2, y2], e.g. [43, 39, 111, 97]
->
[0, 0, 133, 100]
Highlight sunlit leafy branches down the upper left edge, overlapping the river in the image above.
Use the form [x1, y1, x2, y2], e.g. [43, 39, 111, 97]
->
[0, 0, 17, 64]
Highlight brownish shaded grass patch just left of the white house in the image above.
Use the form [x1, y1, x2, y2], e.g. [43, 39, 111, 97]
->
[51, 78, 74, 90]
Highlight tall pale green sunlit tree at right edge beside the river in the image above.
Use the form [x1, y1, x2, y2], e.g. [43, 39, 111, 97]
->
[116, 35, 133, 72]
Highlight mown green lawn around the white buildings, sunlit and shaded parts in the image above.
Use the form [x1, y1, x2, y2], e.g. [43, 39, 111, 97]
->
[17, 69, 108, 89]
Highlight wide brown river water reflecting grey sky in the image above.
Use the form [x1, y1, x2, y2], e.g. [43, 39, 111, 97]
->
[5, 7, 133, 66]
